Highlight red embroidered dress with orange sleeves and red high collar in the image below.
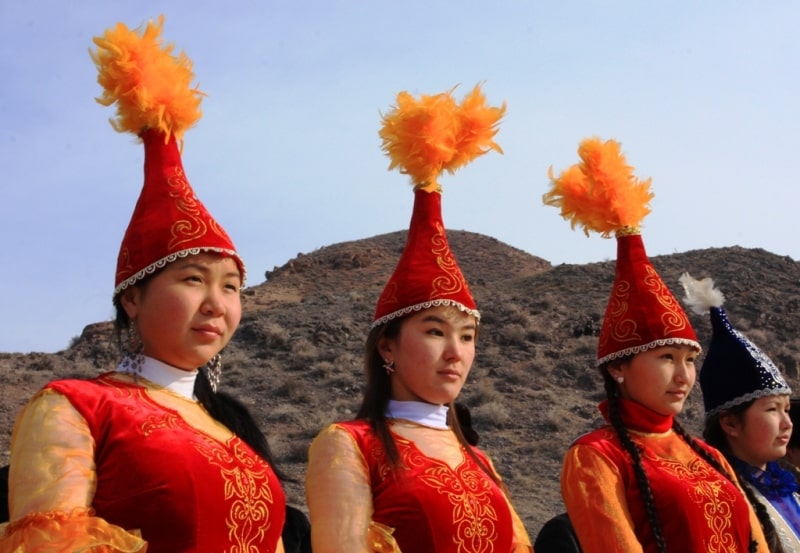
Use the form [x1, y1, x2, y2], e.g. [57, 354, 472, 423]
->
[561, 400, 768, 553]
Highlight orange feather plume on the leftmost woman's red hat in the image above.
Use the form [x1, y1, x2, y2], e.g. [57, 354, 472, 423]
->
[89, 16, 204, 141]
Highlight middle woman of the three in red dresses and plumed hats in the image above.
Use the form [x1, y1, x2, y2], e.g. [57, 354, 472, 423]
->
[306, 83, 532, 553]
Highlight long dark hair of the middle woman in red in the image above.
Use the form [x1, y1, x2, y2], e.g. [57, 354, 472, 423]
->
[356, 317, 508, 494]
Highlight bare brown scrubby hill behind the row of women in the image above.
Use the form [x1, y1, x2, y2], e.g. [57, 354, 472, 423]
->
[0, 231, 800, 536]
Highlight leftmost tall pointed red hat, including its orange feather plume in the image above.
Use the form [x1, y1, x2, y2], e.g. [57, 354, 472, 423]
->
[90, 16, 245, 298]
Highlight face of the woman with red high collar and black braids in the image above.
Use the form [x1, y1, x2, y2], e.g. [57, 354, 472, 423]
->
[609, 345, 697, 415]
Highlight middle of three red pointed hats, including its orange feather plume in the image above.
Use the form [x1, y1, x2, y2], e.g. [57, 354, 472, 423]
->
[372, 86, 505, 328]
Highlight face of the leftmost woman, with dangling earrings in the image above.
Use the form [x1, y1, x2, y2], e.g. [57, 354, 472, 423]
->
[120, 253, 242, 370]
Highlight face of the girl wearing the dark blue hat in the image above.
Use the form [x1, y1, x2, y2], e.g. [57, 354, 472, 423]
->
[720, 395, 792, 469]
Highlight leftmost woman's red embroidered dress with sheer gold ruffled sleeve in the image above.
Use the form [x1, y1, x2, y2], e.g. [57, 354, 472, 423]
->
[0, 374, 285, 553]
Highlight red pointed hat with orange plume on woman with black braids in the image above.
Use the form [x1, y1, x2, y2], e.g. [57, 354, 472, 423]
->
[543, 138, 700, 365]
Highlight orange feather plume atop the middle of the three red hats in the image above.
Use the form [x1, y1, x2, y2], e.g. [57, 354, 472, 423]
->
[379, 85, 506, 187]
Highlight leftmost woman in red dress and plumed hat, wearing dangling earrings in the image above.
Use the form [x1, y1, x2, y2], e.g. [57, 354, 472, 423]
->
[0, 15, 285, 553]
